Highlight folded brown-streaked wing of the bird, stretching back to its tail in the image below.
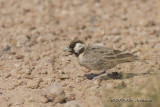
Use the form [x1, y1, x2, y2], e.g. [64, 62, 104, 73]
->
[84, 46, 136, 63]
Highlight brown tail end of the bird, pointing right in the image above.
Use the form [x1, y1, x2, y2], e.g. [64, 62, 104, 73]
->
[116, 53, 139, 63]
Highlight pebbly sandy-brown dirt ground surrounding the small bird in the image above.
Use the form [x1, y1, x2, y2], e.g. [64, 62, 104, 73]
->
[0, 0, 160, 107]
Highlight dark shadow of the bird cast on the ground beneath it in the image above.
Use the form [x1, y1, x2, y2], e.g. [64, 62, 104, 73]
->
[84, 72, 149, 80]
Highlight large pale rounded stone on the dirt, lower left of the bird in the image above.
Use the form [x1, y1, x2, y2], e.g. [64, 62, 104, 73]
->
[46, 82, 65, 103]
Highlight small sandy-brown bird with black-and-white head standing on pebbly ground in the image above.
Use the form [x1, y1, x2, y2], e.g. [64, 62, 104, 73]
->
[66, 40, 137, 78]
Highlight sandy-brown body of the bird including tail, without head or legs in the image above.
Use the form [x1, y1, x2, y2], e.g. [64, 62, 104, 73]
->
[78, 46, 136, 70]
